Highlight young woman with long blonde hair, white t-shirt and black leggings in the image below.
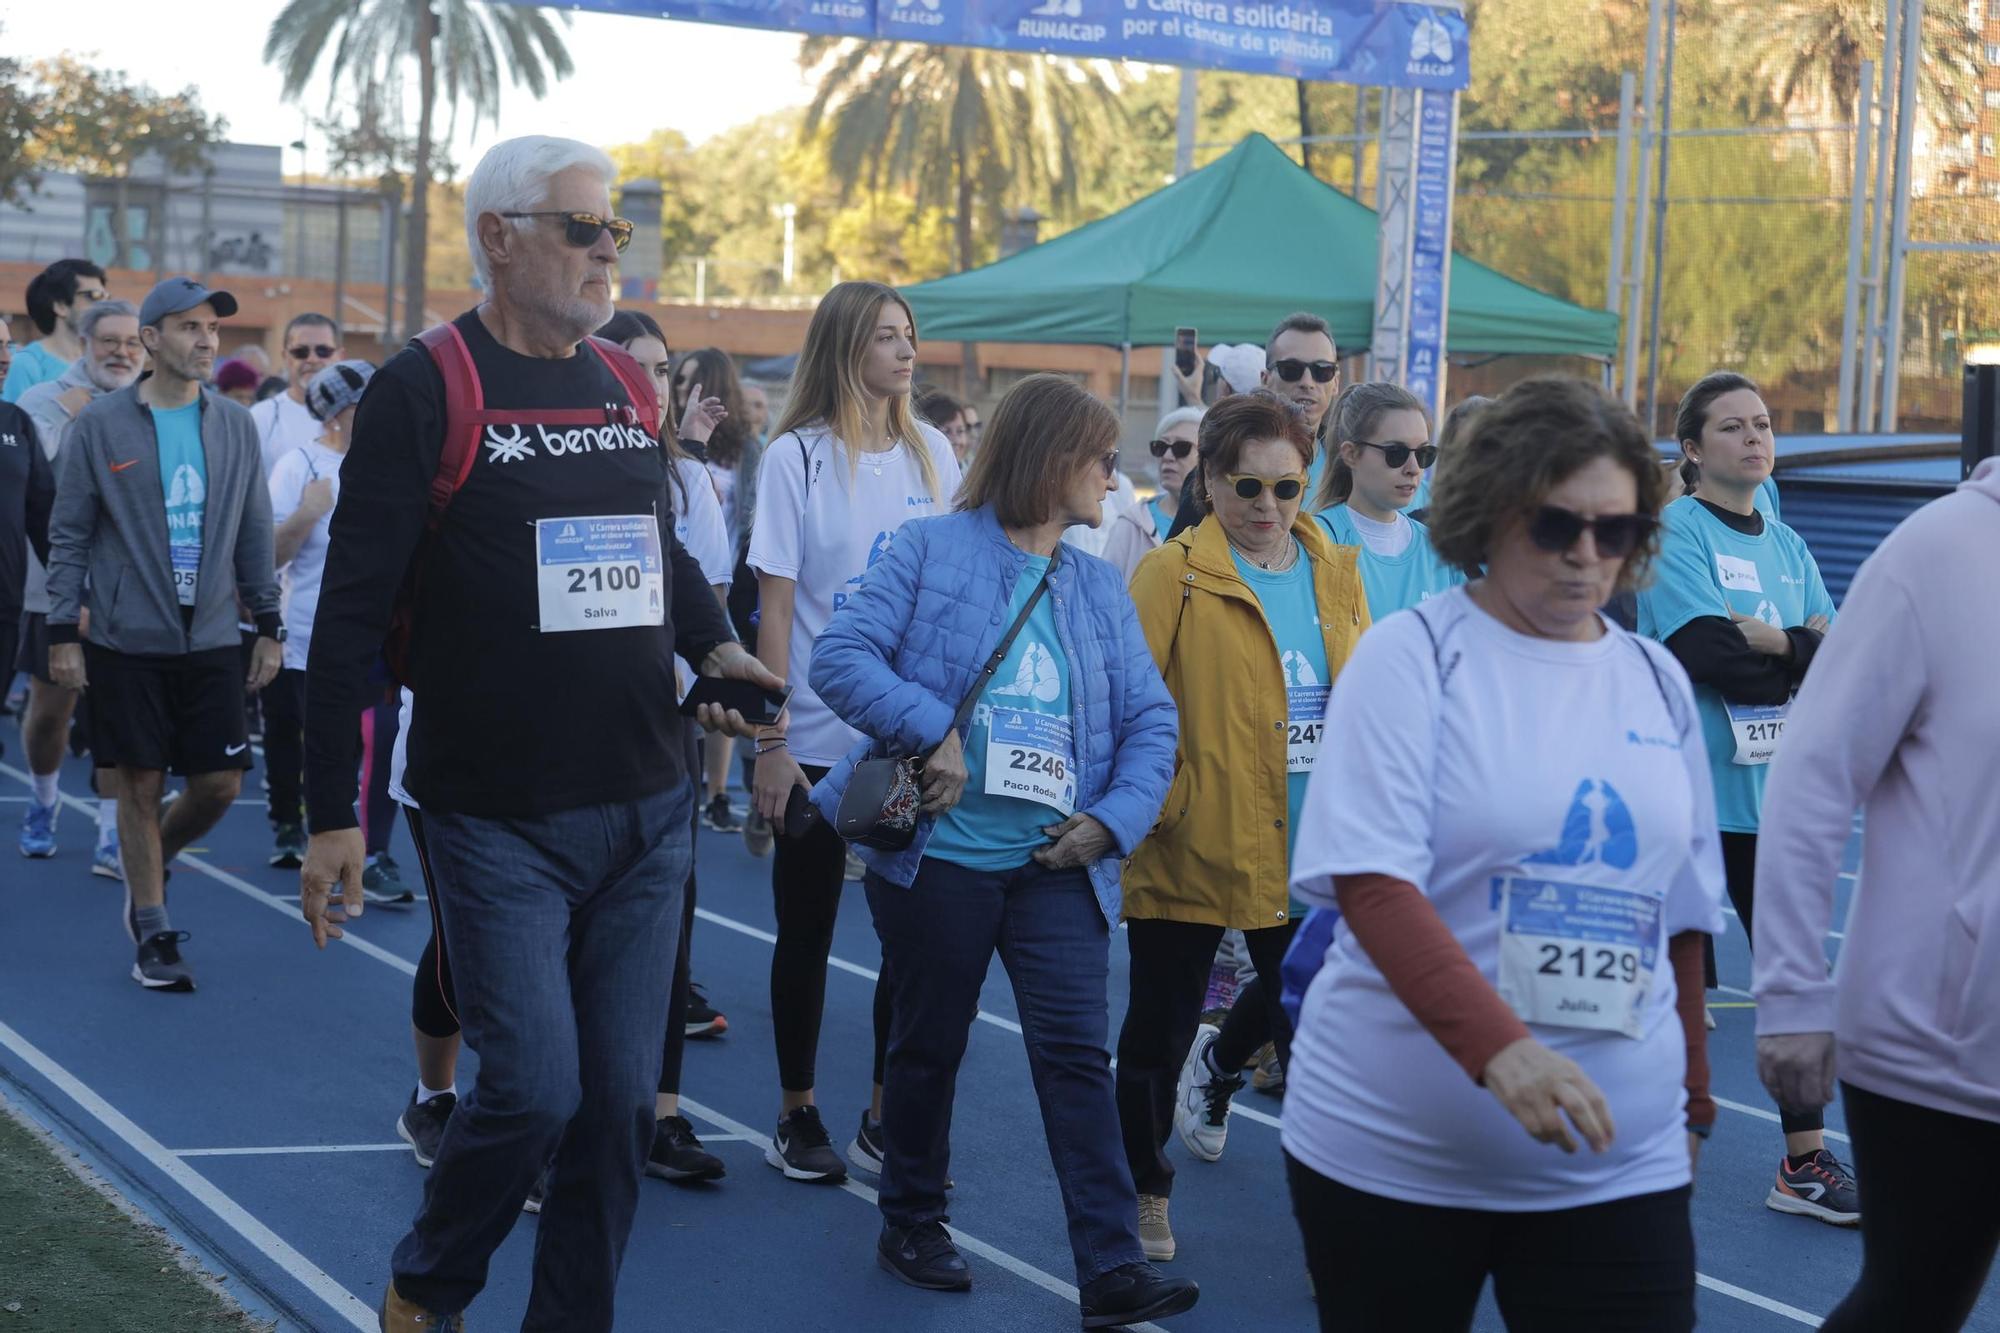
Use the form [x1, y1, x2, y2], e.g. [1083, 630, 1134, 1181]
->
[750, 282, 958, 1183]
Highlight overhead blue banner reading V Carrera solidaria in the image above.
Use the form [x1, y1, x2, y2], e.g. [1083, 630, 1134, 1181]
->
[548, 0, 1468, 92]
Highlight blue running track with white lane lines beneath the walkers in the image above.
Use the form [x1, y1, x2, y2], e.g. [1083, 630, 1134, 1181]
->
[0, 748, 2000, 1333]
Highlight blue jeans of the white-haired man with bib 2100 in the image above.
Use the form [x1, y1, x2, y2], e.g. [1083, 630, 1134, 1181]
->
[392, 785, 694, 1333]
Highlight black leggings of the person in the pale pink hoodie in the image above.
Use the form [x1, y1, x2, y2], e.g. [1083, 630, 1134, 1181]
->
[1822, 1083, 2000, 1333]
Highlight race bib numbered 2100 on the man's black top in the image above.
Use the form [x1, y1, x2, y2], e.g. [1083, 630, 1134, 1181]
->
[534, 514, 666, 634]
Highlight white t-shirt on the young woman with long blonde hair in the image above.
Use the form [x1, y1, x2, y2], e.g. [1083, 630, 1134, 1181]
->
[750, 424, 958, 769]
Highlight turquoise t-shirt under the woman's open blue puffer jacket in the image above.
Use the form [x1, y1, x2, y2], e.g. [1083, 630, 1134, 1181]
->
[924, 556, 1076, 871]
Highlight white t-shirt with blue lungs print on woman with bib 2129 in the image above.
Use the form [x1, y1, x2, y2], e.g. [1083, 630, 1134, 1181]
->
[1282, 588, 1722, 1213]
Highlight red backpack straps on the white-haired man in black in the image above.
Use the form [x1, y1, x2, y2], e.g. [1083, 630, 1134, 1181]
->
[382, 322, 660, 685]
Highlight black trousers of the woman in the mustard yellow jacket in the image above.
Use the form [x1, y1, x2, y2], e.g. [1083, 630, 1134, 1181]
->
[1118, 919, 1294, 1195]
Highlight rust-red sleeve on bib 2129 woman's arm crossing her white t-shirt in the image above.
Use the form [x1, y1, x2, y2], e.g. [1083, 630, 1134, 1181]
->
[1334, 875, 1536, 1083]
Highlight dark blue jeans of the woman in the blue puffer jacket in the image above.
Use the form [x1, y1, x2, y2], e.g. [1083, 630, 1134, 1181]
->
[866, 859, 1146, 1285]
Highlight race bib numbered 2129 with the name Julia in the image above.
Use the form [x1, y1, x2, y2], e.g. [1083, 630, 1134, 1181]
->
[1494, 875, 1660, 1037]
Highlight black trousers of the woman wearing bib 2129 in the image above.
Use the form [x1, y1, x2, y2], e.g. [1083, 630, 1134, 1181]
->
[1284, 1153, 1696, 1333]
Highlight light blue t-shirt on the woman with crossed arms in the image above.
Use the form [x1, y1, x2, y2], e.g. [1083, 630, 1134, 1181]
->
[1638, 494, 1834, 833]
